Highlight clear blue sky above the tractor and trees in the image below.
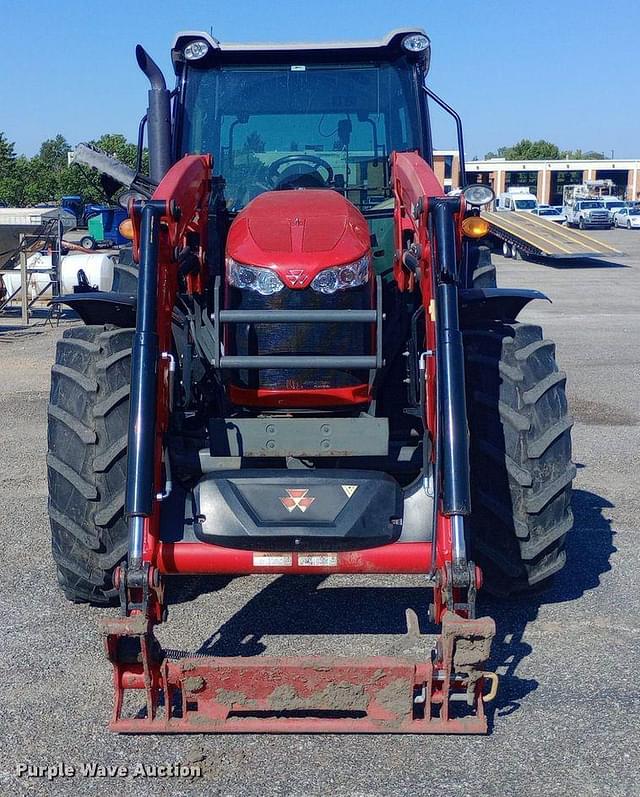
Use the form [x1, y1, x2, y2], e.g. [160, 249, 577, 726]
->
[0, 0, 640, 158]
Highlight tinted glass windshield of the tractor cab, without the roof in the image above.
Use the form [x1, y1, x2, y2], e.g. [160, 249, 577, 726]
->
[181, 63, 422, 211]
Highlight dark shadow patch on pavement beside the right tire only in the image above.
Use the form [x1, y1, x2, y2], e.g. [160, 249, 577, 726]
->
[478, 489, 616, 722]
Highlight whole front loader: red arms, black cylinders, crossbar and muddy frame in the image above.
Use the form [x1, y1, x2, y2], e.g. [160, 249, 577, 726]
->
[102, 153, 496, 733]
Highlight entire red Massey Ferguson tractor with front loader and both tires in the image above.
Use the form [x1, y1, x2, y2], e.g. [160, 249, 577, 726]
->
[48, 30, 574, 733]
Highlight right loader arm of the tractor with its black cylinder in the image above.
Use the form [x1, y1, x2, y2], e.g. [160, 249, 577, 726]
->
[391, 152, 482, 622]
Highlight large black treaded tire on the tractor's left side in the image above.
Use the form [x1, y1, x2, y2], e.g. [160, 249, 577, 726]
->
[47, 326, 134, 605]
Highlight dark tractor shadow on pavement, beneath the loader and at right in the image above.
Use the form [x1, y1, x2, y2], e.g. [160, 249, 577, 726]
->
[162, 490, 616, 723]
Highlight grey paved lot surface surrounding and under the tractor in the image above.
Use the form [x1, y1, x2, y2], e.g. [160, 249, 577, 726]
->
[0, 230, 640, 797]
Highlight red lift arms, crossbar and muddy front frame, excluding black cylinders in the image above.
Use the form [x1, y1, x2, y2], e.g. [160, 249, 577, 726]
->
[102, 153, 497, 733]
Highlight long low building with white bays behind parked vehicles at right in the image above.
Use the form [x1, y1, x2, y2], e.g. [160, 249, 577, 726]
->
[434, 150, 640, 205]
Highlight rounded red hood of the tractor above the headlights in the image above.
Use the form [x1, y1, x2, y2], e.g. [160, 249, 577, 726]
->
[227, 188, 371, 288]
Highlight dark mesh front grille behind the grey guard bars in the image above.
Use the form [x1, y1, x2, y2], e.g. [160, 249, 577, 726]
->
[225, 285, 374, 390]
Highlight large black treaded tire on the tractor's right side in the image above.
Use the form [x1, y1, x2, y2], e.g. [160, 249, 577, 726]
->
[464, 322, 576, 595]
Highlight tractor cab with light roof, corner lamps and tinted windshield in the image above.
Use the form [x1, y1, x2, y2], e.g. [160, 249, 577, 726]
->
[173, 31, 431, 213]
